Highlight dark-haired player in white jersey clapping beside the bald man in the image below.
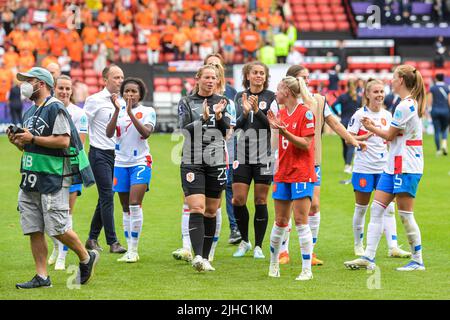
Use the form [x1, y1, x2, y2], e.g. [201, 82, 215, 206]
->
[106, 78, 156, 263]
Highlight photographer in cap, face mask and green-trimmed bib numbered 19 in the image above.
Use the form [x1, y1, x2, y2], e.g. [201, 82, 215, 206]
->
[7, 67, 99, 289]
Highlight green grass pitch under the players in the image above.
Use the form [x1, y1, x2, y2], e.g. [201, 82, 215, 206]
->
[0, 135, 450, 299]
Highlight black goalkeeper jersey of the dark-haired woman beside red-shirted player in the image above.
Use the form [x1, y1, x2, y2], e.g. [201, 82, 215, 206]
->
[234, 89, 278, 164]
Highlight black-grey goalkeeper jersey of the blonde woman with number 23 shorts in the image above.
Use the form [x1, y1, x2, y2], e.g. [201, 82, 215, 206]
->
[178, 93, 232, 166]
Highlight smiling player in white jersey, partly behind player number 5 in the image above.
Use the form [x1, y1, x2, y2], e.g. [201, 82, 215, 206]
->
[347, 79, 411, 258]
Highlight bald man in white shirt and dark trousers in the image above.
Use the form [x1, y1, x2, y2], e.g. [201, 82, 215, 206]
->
[84, 65, 126, 253]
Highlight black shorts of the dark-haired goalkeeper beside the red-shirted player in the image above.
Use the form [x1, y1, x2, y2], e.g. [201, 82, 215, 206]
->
[233, 160, 273, 185]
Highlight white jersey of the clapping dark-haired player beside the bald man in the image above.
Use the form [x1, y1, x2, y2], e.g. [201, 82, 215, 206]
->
[114, 105, 156, 167]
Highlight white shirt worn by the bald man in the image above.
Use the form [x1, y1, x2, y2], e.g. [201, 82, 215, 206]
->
[84, 88, 126, 150]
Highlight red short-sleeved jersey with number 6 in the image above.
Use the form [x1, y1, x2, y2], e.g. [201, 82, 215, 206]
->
[274, 104, 317, 183]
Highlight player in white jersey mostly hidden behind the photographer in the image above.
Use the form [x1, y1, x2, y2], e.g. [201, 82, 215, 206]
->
[48, 75, 88, 270]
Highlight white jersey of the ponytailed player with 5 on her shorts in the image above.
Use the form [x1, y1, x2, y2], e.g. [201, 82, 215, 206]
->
[385, 97, 423, 174]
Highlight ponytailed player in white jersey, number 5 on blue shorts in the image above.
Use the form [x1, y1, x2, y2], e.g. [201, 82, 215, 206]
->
[344, 65, 426, 271]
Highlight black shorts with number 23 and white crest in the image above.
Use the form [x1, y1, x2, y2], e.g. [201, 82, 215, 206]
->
[181, 164, 227, 199]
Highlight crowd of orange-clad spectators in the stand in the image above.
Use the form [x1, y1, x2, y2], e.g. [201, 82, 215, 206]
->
[0, 0, 298, 107]
